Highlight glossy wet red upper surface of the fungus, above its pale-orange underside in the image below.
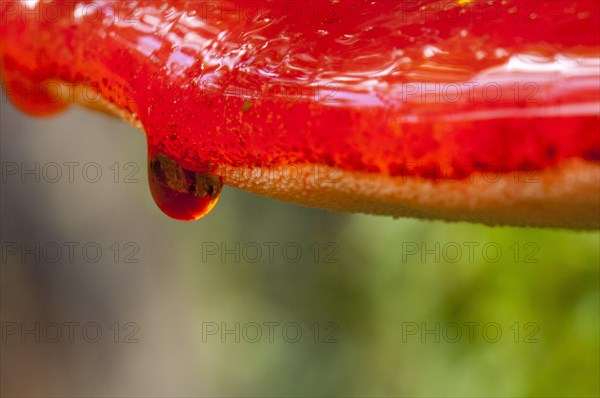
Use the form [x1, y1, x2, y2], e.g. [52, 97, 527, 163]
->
[0, 0, 600, 178]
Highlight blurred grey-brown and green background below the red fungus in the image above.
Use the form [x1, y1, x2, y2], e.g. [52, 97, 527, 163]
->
[0, 101, 600, 397]
